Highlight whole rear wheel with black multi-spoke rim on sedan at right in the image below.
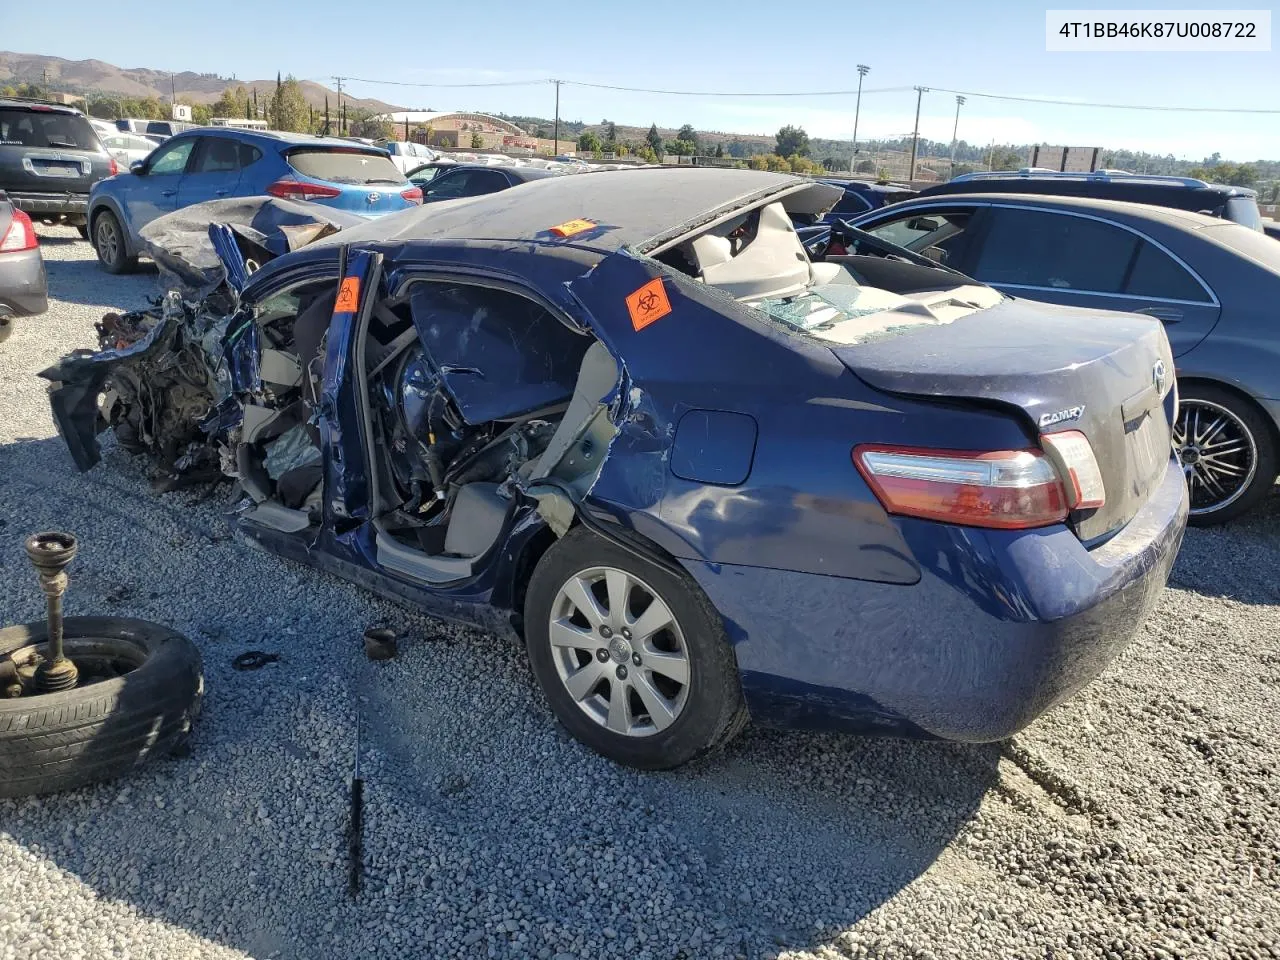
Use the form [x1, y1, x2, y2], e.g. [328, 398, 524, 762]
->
[1174, 384, 1280, 526]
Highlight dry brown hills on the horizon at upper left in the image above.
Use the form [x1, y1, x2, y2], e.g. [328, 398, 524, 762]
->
[0, 50, 403, 113]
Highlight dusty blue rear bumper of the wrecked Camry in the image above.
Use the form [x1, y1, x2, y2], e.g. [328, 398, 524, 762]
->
[685, 461, 1187, 741]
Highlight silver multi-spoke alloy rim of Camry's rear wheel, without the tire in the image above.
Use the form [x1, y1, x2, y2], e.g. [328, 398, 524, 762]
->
[549, 567, 690, 737]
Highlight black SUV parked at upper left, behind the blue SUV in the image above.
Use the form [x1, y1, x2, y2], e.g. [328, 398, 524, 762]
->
[0, 97, 119, 237]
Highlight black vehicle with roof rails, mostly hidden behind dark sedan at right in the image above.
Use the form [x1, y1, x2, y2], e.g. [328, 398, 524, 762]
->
[919, 170, 1262, 230]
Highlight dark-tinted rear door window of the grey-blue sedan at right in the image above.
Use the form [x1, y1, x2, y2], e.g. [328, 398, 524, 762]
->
[974, 207, 1138, 293]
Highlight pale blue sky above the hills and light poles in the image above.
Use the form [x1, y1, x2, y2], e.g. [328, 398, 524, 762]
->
[10, 0, 1280, 160]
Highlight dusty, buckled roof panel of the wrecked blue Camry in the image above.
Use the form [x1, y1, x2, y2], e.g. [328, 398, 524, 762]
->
[304, 166, 841, 253]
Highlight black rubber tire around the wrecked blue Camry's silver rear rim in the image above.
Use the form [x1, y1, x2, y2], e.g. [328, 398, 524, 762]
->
[525, 526, 746, 771]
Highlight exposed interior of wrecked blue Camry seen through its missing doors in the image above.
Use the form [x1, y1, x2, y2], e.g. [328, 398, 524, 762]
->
[234, 271, 618, 582]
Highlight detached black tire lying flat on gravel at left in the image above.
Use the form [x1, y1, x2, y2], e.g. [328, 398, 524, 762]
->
[0, 617, 204, 797]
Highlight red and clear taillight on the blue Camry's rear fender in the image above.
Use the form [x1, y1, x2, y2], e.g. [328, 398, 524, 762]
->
[854, 444, 1070, 530]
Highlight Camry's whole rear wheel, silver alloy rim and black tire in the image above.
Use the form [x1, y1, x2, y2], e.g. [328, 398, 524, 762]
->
[525, 527, 746, 769]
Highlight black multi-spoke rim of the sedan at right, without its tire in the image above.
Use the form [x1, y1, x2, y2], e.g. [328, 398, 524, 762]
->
[1174, 398, 1258, 516]
